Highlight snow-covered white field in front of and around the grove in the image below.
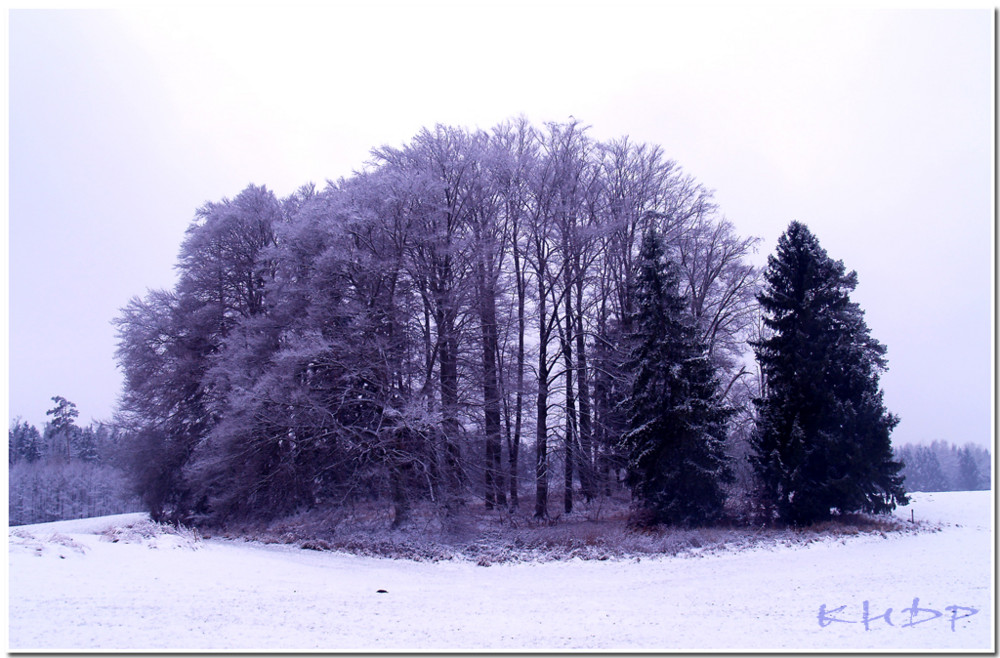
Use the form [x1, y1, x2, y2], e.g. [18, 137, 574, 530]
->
[9, 492, 994, 651]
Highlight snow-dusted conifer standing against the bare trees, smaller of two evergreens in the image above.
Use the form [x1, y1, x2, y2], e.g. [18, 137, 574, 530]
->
[622, 230, 730, 525]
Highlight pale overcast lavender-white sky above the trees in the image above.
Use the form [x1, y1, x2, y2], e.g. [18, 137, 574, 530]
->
[3, 1, 994, 445]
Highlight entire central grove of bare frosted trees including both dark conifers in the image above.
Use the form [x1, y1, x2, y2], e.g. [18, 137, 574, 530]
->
[97, 119, 940, 525]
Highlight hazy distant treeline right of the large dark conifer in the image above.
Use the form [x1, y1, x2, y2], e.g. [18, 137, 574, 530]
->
[895, 441, 991, 491]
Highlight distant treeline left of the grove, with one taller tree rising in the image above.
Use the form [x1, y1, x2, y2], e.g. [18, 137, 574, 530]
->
[7, 396, 143, 525]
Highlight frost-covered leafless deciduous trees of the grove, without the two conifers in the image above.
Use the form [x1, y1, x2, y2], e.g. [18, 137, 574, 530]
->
[111, 120, 757, 522]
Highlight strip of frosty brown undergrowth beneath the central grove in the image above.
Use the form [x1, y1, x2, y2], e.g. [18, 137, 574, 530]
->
[207, 492, 940, 566]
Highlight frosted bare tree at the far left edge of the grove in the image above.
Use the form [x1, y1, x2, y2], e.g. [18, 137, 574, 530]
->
[116, 185, 283, 520]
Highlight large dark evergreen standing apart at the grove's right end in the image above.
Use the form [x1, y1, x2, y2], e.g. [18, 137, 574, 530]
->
[752, 222, 908, 524]
